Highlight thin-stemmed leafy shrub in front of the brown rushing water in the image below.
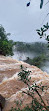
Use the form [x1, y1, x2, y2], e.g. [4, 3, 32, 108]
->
[18, 66, 49, 111]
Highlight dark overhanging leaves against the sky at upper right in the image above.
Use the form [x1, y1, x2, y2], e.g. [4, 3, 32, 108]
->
[27, 0, 49, 44]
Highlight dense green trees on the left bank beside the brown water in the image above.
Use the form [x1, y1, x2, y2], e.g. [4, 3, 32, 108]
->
[0, 25, 14, 56]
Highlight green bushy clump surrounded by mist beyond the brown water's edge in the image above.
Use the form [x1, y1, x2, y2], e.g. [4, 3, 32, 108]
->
[24, 54, 49, 68]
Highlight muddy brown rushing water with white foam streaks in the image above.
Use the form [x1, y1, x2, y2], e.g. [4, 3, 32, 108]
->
[0, 56, 49, 111]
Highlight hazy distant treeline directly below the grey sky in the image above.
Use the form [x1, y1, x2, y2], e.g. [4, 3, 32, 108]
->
[15, 42, 48, 54]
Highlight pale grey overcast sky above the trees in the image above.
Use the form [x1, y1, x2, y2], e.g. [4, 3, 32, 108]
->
[0, 0, 49, 42]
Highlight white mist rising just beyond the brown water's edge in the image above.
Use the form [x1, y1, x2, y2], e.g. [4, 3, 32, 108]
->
[12, 52, 49, 74]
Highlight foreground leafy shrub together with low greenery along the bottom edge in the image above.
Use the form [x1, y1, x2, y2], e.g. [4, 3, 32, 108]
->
[10, 65, 49, 111]
